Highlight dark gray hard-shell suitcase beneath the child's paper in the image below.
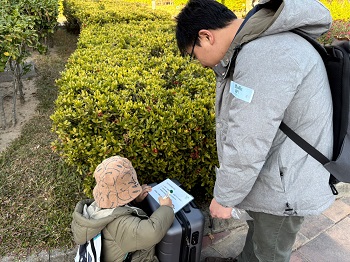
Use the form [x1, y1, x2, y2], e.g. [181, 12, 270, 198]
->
[143, 179, 204, 262]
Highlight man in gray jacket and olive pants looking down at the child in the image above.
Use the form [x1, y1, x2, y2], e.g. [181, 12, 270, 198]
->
[176, 0, 334, 262]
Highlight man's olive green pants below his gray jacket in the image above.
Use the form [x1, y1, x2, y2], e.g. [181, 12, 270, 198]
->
[237, 211, 304, 262]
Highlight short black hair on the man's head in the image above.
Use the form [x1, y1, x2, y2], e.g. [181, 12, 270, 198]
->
[176, 0, 237, 55]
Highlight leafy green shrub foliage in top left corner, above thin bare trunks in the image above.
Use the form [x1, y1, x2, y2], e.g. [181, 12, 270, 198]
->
[0, 0, 58, 72]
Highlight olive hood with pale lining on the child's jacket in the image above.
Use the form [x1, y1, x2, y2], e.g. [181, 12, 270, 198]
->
[71, 199, 147, 245]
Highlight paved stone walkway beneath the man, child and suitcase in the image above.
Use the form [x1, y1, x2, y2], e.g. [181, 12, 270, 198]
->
[0, 184, 350, 262]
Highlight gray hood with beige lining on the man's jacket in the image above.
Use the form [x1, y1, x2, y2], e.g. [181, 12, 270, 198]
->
[222, 0, 332, 67]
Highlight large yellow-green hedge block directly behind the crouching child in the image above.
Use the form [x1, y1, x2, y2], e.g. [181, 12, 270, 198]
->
[52, 21, 217, 195]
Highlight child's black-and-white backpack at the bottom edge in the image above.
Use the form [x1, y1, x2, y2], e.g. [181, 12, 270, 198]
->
[74, 232, 133, 262]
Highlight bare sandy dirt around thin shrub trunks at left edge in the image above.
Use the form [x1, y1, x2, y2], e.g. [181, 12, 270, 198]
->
[0, 78, 38, 153]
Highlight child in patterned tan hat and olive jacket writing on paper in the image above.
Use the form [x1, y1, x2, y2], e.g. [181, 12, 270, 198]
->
[72, 156, 175, 262]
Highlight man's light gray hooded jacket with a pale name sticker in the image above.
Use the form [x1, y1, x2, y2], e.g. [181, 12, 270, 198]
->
[214, 0, 334, 216]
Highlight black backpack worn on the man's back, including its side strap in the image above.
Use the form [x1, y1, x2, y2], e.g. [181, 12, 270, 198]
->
[280, 30, 350, 195]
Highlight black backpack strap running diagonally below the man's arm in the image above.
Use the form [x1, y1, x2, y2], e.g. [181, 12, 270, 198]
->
[280, 122, 330, 165]
